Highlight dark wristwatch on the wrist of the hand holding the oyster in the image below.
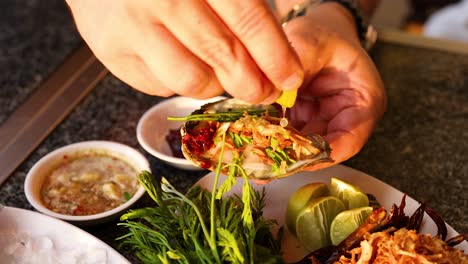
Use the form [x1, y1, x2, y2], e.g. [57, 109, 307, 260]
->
[281, 0, 377, 50]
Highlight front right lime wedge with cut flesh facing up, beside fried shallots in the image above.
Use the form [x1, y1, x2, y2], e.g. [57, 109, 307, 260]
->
[330, 206, 372, 246]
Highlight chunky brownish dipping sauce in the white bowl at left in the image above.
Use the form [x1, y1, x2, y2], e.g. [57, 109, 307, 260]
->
[41, 150, 139, 215]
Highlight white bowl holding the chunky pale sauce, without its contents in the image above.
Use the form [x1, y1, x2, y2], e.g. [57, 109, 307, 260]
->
[24, 141, 150, 226]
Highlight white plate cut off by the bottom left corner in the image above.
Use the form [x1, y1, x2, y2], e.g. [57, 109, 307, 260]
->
[0, 205, 130, 264]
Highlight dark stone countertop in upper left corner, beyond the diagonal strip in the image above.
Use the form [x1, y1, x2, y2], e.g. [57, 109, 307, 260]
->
[0, 0, 82, 125]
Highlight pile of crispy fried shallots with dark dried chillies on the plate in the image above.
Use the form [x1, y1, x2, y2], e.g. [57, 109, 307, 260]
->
[296, 195, 468, 264]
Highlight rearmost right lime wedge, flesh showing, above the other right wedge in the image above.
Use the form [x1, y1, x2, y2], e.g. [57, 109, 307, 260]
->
[330, 178, 369, 209]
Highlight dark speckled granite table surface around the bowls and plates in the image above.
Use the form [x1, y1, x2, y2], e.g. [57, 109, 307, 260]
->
[0, 1, 468, 262]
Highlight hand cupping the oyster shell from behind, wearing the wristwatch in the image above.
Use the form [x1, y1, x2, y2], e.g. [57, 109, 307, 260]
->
[285, 3, 386, 169]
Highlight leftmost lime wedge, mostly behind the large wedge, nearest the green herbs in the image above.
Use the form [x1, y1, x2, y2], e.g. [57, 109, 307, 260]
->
[285, 182, 329, 235]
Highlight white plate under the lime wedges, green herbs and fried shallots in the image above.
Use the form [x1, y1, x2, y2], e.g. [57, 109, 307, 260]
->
[197, 165, 468, 262]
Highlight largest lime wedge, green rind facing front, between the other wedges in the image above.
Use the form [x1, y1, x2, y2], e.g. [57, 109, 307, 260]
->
[296, 196, 345, 251]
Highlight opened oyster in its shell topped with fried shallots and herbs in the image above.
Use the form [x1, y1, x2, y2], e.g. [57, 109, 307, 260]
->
[176, 99, 331, 179]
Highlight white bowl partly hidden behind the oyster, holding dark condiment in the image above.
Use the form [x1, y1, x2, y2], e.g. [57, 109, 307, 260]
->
[137, 96, 226, 170]
